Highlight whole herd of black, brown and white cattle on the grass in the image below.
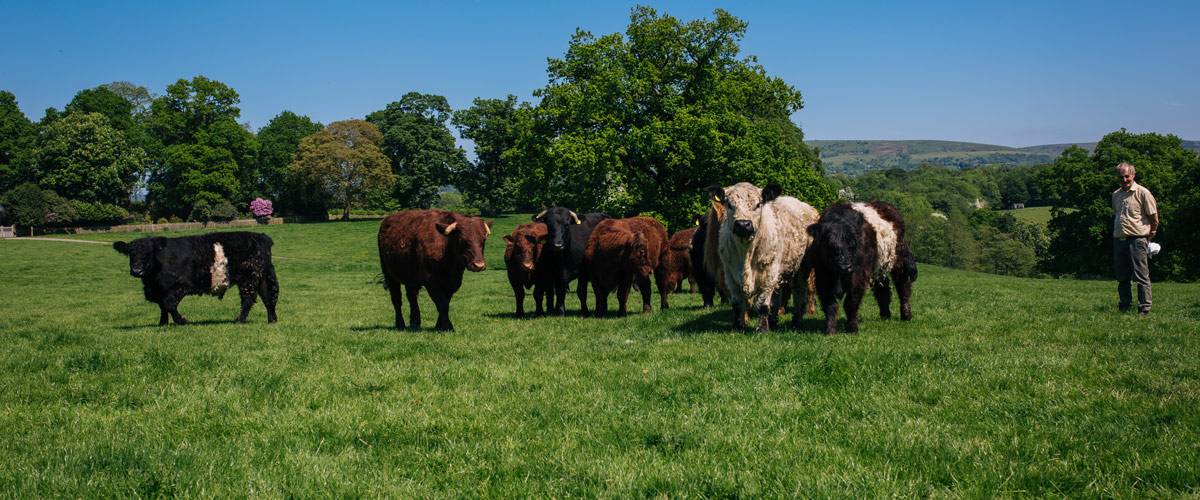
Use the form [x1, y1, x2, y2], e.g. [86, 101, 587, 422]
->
[113, 182, 917, 333]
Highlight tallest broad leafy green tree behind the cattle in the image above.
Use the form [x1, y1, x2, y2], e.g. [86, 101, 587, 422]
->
[512, 6, 834, 224]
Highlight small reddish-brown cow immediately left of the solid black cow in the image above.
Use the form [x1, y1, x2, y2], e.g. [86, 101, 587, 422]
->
[504, 222, 554, 318]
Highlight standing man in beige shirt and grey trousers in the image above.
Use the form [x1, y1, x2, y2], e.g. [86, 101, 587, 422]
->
[1112, 162, 1158, 314]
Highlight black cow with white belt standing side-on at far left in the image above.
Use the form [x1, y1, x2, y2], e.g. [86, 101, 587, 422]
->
[113, 231, 280, 326]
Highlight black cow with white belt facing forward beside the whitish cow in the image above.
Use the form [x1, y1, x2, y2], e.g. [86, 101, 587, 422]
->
[804, 201, 917, 333]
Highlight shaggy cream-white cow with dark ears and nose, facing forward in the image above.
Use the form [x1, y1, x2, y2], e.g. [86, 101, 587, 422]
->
[710, 182, 820, 331]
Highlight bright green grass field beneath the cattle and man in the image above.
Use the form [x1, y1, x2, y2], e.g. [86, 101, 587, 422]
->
[0, 217, 1200, 498]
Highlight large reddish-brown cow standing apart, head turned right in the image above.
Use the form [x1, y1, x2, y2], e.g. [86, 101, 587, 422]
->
[379, 210, 492, 330]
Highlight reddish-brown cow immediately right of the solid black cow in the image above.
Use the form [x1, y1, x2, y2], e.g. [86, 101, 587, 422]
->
[583, 217, 671, 315]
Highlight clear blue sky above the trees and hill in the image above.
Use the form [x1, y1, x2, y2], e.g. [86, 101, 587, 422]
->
[0, 0, 1200, 146]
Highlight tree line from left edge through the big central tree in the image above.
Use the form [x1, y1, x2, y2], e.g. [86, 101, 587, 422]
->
[0, 7, 834, 230]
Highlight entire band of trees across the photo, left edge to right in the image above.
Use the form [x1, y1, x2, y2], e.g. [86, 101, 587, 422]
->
[0, 6, 1200, 279]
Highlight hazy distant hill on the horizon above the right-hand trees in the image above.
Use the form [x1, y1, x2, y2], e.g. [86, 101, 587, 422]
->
[805, 140, 1200, 175]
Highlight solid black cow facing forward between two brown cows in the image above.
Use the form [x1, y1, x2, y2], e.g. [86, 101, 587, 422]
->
[533, 206, 608, 315]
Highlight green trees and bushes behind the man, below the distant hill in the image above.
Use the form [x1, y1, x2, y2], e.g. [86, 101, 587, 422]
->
[830, 129, 1200, 281]
